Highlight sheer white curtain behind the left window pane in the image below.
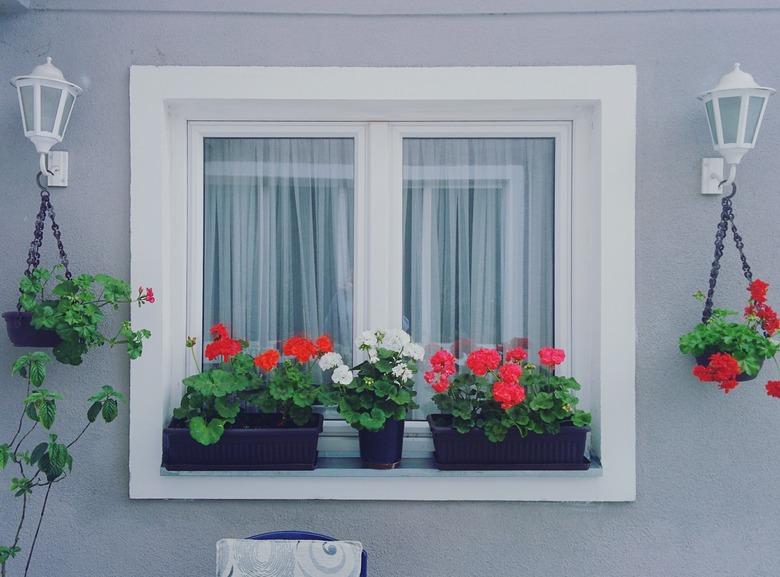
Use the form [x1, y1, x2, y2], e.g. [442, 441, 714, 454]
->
[203, 138, 354, 360]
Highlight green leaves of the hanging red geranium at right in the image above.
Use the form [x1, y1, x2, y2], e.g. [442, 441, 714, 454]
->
[680, 309, 780, 377]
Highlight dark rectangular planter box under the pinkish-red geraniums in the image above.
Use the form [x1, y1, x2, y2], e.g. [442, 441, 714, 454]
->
[428, 415, 590, 471]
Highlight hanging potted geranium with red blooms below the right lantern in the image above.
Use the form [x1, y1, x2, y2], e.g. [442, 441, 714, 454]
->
[680, 279, 780, 396]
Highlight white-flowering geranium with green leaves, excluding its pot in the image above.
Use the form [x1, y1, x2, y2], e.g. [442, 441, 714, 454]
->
[320, 329, 425, 431]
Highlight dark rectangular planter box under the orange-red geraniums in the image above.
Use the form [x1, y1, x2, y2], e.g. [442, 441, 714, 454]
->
[162, 413, 322, 471]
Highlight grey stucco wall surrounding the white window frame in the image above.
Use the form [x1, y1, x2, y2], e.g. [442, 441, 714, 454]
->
[0, 0, 780, 577]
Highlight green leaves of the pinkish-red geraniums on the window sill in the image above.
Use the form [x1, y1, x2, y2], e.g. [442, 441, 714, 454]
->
[433, 362, 591, 443]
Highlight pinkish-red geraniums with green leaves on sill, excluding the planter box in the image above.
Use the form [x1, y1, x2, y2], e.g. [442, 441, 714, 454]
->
[424, 347, 591, 443]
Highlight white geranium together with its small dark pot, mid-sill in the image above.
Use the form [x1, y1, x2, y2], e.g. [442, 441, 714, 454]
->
[320, 329, 425, 469]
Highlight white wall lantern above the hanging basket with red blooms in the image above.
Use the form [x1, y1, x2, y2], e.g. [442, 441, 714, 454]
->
[699, 63, 775, 184]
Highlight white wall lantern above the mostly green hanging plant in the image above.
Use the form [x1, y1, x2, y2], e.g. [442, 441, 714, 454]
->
[11, 57, 82, 174]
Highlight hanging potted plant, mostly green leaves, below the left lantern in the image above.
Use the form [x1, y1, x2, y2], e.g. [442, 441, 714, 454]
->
[3, 265, 155, 365]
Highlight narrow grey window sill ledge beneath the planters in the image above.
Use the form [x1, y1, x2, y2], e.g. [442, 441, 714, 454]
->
[160, 456, 602, 479]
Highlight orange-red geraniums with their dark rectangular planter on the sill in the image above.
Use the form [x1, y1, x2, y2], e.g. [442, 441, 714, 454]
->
[163, 324, 335, 471]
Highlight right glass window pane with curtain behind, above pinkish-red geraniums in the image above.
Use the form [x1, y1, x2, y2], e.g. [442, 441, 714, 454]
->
[403, 138, 555, 418]
